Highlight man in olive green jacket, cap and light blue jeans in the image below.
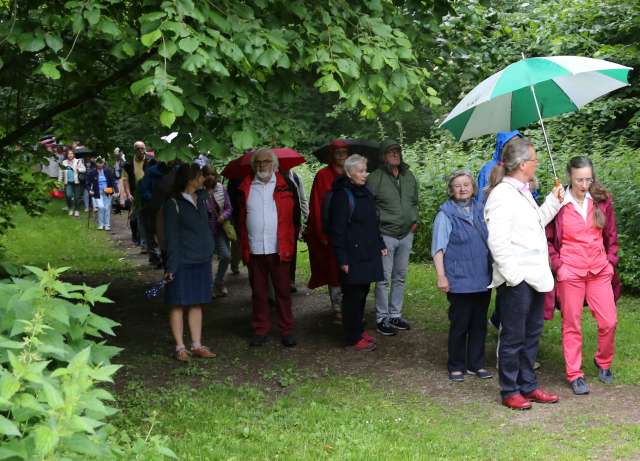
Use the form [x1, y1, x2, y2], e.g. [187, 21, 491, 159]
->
[367, 140, 418, 336]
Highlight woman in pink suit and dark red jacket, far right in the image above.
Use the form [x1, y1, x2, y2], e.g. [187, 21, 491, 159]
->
[547, 157, 620, 395]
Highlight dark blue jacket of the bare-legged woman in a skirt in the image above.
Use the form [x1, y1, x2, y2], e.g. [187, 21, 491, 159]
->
[164, 191, 213, 274]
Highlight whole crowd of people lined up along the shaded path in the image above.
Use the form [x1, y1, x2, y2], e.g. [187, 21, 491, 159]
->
[46, 131, 620, 409]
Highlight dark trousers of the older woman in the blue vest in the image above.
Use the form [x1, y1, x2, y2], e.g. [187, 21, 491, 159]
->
[447, 291, 491, 372]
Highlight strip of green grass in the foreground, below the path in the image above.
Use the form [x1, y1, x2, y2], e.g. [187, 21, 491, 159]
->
[119, 377, 640, 461]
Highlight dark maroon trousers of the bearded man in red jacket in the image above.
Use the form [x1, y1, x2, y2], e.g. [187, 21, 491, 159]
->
[248, 253, 293, 336]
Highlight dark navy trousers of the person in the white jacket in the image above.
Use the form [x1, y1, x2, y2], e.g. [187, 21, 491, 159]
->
[497, 282, 544, 398]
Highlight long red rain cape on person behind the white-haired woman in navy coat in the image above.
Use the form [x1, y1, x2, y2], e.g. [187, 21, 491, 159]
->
[307, 165, 340, 288]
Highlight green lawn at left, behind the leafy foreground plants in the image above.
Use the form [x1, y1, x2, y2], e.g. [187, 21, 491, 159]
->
[0, 200, 131, 277]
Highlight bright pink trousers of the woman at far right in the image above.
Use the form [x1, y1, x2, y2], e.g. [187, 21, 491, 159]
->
[557, 265, 618, 382]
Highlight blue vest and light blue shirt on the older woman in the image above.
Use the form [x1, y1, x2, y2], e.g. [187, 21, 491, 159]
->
[440, 200, 491, 293]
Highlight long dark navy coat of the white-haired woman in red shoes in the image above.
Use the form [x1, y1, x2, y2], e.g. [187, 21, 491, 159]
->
[330, 176, 386, 284]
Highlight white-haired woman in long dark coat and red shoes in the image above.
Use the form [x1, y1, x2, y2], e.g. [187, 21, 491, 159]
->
[330, 154, 387, 351]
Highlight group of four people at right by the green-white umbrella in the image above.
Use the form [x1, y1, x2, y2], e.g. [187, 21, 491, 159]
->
[431, 131, 620, 410]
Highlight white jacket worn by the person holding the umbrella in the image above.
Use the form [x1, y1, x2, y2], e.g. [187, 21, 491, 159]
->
[484, 178, 562, 292]
